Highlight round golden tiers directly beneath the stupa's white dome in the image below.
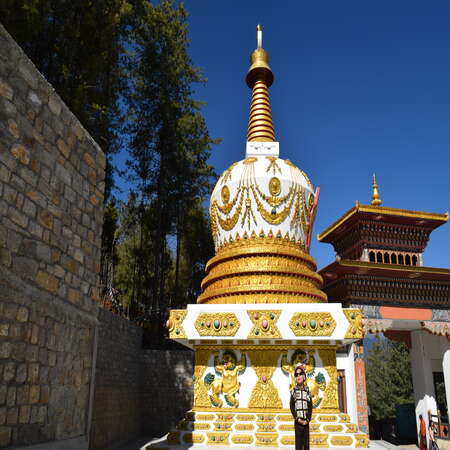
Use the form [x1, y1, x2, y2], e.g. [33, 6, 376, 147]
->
[197, 236, 327, 303]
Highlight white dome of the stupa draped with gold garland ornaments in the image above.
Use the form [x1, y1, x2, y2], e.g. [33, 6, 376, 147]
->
[210, 153, 316, 250]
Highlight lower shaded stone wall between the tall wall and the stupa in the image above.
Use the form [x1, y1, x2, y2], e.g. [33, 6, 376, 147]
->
[90, 310, 193, 450]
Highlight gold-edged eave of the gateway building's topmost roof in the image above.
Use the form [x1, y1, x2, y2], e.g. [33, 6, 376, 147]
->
[317, 204, 448, 242]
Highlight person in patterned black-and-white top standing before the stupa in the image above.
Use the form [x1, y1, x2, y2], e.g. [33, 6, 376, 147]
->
[290, 365, 312, 450]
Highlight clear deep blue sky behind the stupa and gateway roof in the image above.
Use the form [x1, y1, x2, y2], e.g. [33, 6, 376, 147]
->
[117, 0, 450, 268]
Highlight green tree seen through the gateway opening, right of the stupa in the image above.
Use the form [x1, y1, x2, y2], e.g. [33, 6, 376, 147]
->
[366, 335, 414, 419]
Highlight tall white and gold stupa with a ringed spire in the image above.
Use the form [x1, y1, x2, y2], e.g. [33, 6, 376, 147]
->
[166, 26, 368, 447]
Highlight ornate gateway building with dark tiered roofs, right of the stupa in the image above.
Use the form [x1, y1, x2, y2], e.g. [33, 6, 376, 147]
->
[318, 175, 450, 437]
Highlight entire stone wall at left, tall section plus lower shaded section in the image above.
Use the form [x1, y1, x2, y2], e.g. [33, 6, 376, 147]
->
[0, 25, 193, 450]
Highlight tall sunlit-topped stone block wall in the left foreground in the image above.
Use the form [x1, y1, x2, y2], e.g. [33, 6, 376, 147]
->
[0, 25, 105, 448]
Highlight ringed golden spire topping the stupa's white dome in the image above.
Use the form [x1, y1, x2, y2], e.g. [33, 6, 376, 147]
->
[245, 25, 275, 142]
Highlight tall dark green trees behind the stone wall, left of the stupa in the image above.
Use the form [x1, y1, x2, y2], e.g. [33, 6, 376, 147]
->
[0, 0, 219, 330]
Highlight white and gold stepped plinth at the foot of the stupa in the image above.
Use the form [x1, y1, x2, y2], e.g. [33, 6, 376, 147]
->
[147, 409, 369, 450]
